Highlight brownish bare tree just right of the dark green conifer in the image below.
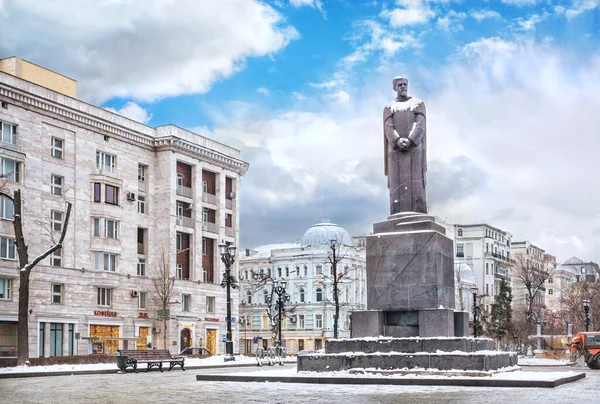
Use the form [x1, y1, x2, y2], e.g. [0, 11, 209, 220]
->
[509, 253, 556, 323]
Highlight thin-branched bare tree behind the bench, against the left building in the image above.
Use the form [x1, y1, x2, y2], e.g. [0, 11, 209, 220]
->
[150, 250, 177, 349]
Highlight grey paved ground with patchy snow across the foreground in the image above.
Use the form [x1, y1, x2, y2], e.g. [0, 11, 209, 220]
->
[0, 365, 600, 404]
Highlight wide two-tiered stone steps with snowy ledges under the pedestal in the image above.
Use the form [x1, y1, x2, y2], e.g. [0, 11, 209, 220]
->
[297, 338, 517, 372]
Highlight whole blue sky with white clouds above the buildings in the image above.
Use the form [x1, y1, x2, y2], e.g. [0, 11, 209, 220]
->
[0, 0, 600, 262]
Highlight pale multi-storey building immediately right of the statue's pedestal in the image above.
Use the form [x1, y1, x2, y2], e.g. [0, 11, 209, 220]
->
[454, 224, 512, 306]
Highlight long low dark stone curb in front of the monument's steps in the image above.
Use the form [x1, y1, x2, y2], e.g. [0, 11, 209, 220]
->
[196, 373, 585, 388]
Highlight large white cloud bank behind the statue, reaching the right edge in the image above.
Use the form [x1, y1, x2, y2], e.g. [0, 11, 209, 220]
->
[206, 38, 600, 259]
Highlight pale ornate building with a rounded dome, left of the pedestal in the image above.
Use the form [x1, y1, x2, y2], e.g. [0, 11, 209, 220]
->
[237, 221, 367, 353]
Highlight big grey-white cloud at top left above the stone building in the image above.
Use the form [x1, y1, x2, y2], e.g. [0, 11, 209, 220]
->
[0, 0, 298, 103]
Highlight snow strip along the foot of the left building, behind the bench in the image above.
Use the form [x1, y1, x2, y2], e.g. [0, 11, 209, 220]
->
[0, 355, 294, 374]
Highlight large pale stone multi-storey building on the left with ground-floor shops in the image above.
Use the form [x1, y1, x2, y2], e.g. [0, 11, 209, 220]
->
[0, 58, 248, 358]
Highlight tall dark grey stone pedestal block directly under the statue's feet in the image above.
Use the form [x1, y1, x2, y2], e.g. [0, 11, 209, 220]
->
[366, 213, 455, 337]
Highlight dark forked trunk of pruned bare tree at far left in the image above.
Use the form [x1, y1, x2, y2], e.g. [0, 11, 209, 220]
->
[0, 187, 72, 365]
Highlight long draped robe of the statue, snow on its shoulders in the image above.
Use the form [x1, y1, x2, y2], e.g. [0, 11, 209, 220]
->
[383, 98, 427, 215]
